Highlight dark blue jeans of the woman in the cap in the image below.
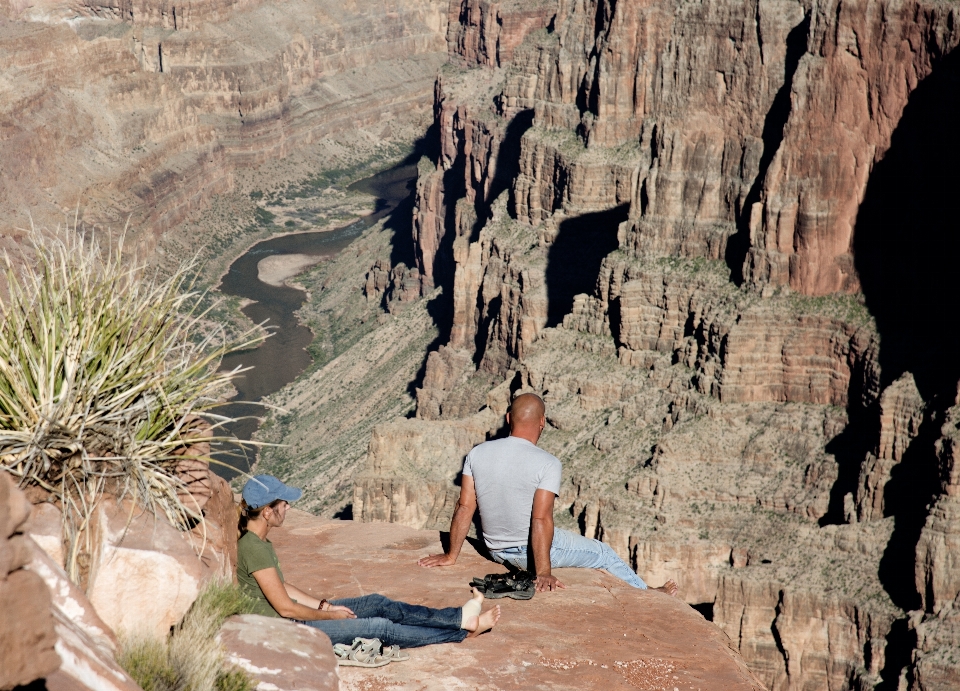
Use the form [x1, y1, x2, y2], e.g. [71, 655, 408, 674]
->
[304, 595, 468, 648]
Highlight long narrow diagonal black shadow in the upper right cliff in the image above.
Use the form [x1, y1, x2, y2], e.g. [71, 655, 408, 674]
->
[724, 14, 810, 285]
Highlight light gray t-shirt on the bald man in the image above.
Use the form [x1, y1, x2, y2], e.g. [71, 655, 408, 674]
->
[463, 437, 561, 550]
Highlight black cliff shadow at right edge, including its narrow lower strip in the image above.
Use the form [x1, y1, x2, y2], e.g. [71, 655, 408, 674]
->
[854, 44, 960, 688]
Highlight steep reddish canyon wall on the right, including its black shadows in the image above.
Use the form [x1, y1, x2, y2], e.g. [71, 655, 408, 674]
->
[353, 0, 960, 690]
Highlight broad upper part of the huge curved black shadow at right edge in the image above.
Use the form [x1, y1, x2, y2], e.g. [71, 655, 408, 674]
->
[853, 51, 960, 402]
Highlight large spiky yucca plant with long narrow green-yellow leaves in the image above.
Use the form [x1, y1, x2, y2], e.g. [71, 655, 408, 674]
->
[0, 228, 262, 583]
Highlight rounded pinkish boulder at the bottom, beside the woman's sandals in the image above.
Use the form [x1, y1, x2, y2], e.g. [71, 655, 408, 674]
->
[220, 614, 340, 691]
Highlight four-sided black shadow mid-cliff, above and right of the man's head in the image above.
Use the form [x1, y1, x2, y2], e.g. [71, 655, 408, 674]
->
[546, 204, 630, 327]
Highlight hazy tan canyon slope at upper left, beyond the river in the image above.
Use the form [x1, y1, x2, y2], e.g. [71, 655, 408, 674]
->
[0, 0, 447, 254]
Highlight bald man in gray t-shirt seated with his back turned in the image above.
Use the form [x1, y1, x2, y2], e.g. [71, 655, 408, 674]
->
[419, 393, 677, 595]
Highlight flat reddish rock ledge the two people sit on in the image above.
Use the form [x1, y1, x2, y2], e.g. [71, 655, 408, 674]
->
[270, 510, 762, 691]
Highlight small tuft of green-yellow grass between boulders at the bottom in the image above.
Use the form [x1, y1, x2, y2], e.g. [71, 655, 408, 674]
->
[117, 583, 256, 691]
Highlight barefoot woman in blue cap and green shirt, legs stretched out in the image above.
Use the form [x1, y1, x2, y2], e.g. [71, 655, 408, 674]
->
[237, 475, 500, 662]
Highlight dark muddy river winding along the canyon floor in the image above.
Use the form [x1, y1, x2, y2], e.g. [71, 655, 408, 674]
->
[214, 165, 417, 479]
